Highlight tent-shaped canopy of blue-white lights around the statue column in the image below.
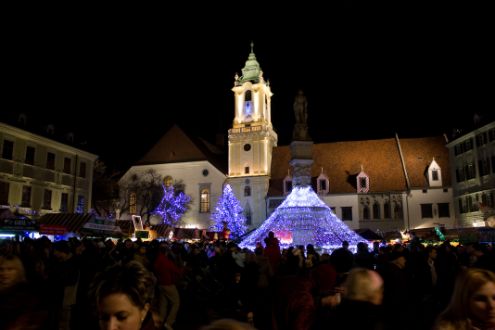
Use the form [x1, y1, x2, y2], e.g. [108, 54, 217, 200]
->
[239, 186, 368, 250]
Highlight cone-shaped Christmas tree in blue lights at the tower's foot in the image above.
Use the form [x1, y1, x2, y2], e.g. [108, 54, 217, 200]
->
[210, 184, 247, 240]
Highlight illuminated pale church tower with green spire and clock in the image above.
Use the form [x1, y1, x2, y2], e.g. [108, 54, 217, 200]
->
[227, 43, 277, 228]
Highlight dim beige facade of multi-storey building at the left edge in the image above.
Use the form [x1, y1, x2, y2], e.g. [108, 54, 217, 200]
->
[0, 123, 97, 215]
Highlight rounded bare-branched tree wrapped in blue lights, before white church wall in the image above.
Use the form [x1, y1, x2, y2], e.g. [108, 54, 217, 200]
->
[151, 184, 191, 226]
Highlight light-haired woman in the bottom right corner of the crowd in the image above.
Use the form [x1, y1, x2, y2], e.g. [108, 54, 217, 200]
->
[434, 268, 495, 330]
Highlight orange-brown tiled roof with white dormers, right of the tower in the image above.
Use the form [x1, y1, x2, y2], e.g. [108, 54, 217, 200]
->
[269, 136, 450, 196]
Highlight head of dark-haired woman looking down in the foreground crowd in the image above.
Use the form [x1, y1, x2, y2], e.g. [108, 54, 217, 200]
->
[91, 261, 156, 330]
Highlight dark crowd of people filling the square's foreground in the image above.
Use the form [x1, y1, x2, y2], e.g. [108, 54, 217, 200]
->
[0, 233, 495, 330]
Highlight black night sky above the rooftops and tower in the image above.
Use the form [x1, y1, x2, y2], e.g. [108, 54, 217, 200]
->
[2, 6, 495, 171]
